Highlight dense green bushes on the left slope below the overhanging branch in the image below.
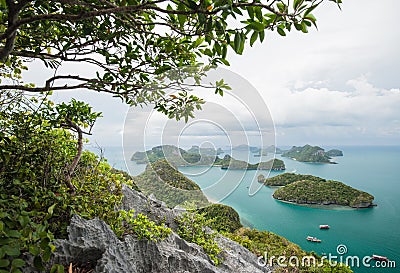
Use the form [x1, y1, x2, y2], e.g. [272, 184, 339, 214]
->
[0, 97, 170, 272]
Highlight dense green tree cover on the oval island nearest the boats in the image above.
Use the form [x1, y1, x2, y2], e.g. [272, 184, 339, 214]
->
[273, 178, 374, 207]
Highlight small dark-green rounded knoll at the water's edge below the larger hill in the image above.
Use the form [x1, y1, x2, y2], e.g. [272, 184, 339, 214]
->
[197, 204, 242, 232]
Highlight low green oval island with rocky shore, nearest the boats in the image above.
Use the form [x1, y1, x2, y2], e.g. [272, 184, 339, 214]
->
[264, 173, 375, 208]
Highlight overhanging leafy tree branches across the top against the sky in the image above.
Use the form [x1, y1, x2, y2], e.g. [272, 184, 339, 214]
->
[0, 0, 341, 119]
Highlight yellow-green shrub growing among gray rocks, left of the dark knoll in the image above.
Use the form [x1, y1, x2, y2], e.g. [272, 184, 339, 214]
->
[176, 212, 221, 265]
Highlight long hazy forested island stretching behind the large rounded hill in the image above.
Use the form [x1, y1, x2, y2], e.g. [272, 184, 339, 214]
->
[131, 145, 286, 171]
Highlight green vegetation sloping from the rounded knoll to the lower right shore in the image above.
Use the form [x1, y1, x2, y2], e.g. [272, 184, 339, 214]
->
[177, 200, 352, 273]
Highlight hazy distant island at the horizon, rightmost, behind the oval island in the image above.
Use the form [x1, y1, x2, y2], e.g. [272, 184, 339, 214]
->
[282, 144, 343, 164]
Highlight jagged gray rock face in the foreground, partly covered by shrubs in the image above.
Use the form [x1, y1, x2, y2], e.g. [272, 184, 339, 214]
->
[53, 188, 271, 273]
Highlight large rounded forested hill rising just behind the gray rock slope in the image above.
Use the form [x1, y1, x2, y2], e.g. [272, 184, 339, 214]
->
[133, 160, 209, 208]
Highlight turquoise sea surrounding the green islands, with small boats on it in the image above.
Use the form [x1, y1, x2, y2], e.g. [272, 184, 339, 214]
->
[91, 146, 400, 273]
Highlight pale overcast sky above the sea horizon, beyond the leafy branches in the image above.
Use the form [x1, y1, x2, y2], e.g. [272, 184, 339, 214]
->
[26, 0, 400, 149]
